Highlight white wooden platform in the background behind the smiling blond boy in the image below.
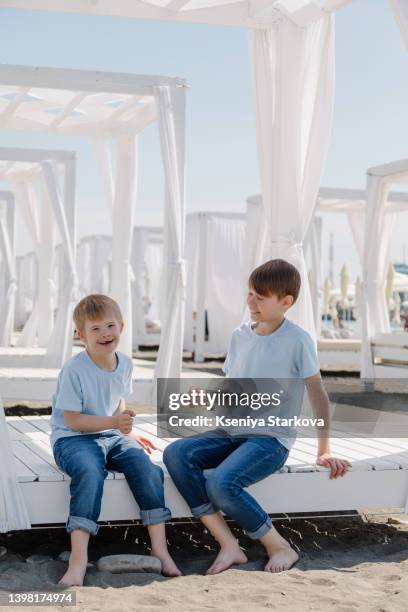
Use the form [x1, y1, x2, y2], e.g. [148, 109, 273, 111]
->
[0, 359, 215, 404]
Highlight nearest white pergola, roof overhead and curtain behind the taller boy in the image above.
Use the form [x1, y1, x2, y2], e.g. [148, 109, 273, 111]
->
[0, 0, 408, 346]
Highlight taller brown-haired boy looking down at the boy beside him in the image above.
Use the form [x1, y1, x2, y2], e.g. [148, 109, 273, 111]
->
[164, 259, 350, 574]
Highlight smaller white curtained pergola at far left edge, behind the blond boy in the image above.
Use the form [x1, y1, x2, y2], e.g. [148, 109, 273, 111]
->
[0, 148, 77, 367]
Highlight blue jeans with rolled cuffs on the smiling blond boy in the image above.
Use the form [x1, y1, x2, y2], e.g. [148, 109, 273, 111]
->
[53, 432, 171, 535]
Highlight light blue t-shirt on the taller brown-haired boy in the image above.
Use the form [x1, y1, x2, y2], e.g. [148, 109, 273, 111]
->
[223, 319, 320, 449]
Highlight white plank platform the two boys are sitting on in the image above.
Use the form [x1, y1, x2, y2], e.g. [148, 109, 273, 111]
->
[7, 415, 408, 525]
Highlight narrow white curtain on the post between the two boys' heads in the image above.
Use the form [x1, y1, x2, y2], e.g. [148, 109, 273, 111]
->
[154, 86, 186, 379]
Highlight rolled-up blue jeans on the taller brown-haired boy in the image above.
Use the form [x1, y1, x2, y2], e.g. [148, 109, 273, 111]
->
[163, 433, 289, 539]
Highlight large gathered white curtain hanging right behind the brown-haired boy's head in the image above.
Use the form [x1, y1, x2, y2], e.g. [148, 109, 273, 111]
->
[251, 15, 334, 346]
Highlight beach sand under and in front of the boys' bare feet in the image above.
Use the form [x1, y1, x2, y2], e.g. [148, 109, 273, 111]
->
[0, 512, 408, 612]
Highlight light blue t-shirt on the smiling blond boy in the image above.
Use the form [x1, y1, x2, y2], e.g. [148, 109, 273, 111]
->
[51, 351, 133, 447]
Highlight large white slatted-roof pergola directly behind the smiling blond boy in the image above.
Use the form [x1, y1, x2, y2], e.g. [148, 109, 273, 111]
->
[0, 65, 186, 377]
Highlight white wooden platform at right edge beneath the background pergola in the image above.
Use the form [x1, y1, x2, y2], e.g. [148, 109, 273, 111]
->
[371, 331, 408, 378]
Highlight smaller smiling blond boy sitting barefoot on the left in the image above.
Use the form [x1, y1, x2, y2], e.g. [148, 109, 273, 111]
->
[51, 295, 181, 586]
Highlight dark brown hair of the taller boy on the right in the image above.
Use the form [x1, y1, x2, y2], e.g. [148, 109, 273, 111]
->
[249, 259, 301, 303]
